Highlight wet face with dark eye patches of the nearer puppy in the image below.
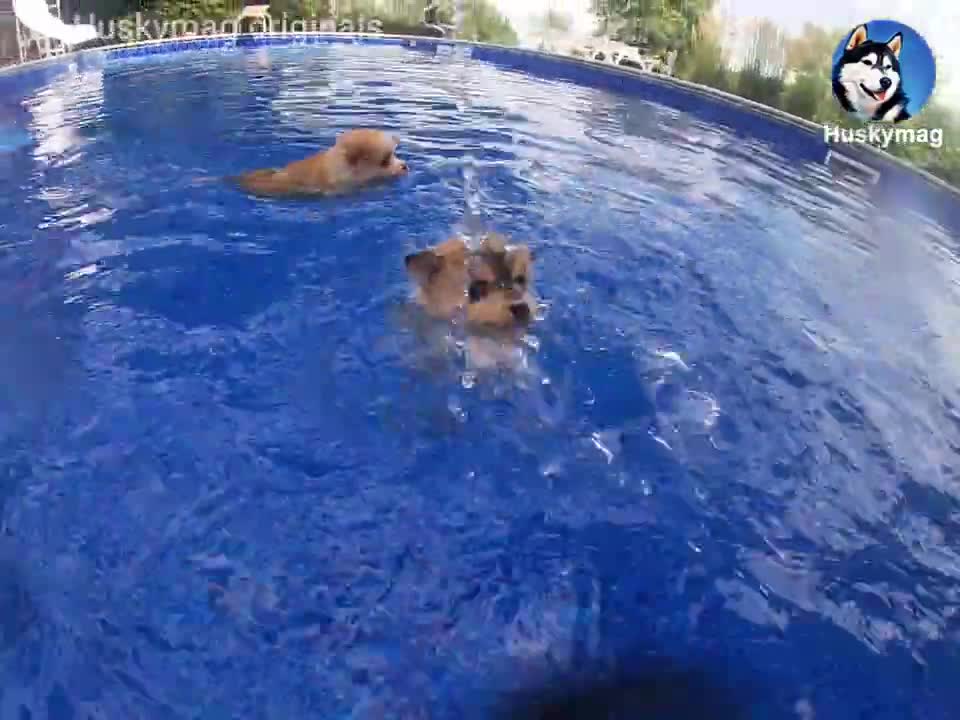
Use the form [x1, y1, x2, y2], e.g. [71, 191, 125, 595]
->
[467, 234, 536, 329]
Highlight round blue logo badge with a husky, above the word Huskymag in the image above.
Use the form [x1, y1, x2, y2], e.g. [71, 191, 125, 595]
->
[833, 20, 937, 123]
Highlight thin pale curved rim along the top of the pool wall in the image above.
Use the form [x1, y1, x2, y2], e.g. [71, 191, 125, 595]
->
[0, 31, 960, 199]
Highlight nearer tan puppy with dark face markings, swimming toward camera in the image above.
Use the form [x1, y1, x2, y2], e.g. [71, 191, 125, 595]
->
[404, 234, 536, 369]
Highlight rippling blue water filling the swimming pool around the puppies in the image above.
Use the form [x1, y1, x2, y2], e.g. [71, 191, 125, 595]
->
[0, 36, 960, 720]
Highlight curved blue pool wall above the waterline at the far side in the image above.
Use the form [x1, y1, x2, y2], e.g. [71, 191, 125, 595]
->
[0, 32, 960, 233]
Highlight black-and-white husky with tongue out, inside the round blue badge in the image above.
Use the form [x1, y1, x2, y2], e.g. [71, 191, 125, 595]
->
[833, 25, 910, 122]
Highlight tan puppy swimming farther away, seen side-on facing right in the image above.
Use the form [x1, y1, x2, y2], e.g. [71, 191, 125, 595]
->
[233, 129, 407, 197]
